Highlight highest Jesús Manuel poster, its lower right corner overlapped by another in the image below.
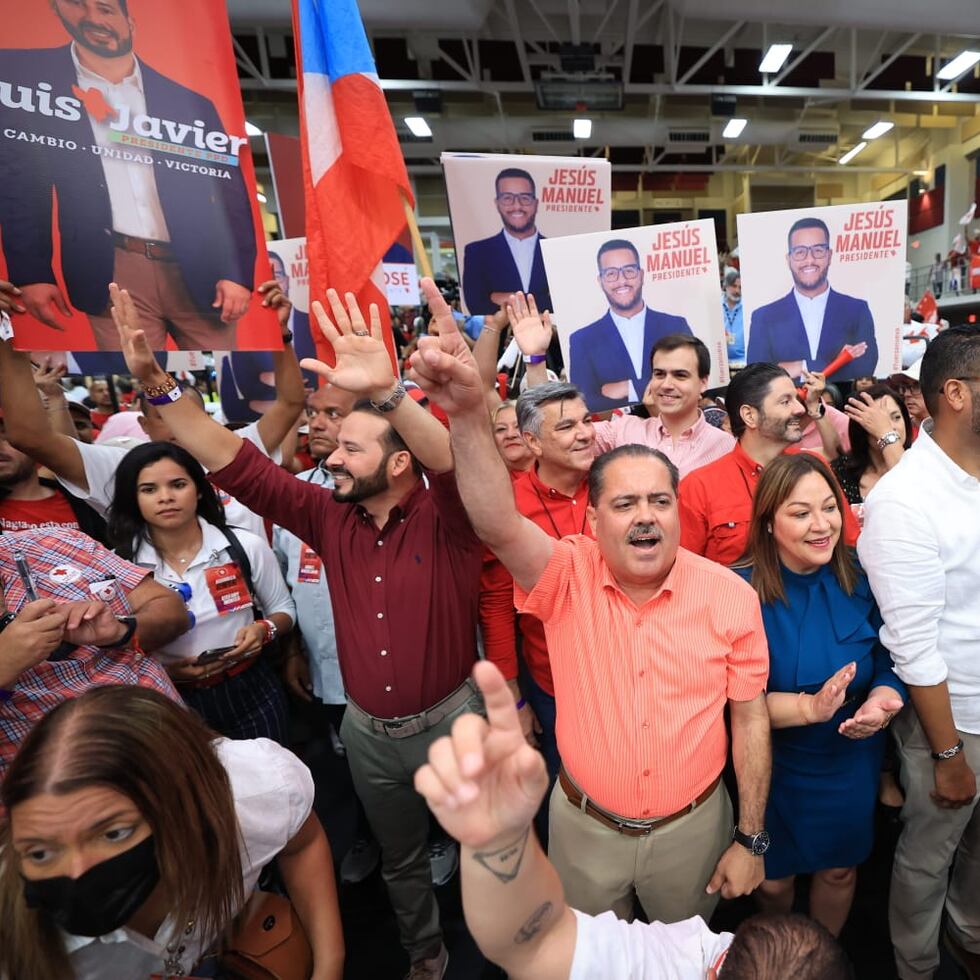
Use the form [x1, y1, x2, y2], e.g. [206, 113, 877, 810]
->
[441, 153, 612, 314]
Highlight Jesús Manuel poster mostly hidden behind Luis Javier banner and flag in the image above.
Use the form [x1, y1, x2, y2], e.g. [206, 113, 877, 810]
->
[214, 238, 319, 422]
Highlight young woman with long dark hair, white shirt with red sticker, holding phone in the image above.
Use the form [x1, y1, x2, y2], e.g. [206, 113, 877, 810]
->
[109, 442, 296, 744]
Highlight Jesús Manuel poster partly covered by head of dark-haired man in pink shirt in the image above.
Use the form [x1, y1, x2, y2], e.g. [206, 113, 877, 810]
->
[541, 218, 728, 412]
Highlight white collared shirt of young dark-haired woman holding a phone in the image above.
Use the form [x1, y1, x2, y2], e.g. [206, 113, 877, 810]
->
[133, 517, 296, 663]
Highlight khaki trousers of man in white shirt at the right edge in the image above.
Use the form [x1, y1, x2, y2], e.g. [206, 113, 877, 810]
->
[888, 706, 980, 980]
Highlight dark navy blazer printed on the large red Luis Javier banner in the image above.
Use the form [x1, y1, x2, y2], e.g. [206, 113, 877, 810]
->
[0, 45, 257, 315]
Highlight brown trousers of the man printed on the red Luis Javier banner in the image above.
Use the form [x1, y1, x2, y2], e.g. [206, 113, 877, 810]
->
[89, 247, 235, 351]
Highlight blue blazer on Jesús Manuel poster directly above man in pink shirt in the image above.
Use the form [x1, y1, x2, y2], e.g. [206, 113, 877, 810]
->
[568, 307, 693, 412]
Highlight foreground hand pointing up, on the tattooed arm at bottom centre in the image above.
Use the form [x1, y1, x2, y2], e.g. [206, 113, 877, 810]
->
[415, 661, 548, 848]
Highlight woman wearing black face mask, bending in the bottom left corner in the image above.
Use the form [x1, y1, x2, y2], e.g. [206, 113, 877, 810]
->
[0, 687, 344, 980]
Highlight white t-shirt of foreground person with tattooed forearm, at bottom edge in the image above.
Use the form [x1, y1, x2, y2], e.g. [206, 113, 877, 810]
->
[568, 912, 732, 980]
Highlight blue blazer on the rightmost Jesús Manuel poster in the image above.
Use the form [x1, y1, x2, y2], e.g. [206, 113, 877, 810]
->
[746, 289, 878, 381]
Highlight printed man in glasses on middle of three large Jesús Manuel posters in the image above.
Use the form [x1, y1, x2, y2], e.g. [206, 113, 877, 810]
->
[569, 238, 692, 412]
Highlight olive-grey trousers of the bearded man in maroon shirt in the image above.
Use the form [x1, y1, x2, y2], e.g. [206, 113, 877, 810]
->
[340, 692, 486, 963]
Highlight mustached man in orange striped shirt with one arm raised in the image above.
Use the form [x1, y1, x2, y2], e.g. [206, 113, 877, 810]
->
[412, 289, 771, 922]
